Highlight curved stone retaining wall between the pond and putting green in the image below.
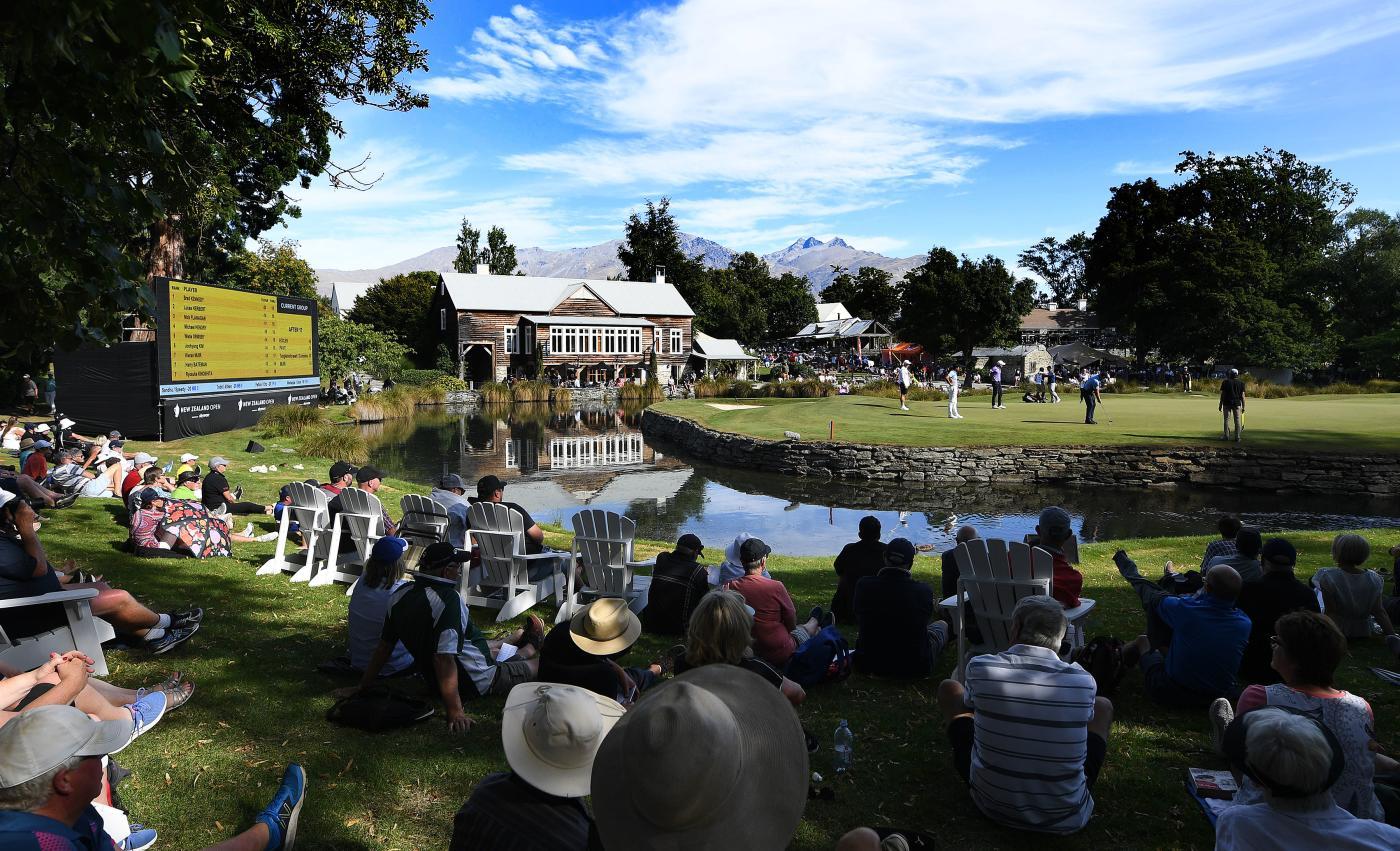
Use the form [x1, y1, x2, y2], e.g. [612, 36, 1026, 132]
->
[641, 409, 1400, 495]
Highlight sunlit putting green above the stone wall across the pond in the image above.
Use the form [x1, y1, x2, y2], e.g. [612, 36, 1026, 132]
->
[657, 393, 1400, 453]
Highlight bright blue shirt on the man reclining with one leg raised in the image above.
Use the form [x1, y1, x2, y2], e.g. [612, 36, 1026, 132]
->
[1156, 593, 1250, 694]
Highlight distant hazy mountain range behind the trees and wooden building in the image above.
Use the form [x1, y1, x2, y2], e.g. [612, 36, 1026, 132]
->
[316, 234, 924, 294]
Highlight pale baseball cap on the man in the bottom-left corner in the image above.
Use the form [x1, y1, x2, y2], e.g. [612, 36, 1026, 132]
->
[0, 705, 134, 788]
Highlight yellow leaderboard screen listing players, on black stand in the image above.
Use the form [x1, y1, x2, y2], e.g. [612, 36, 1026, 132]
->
[154, 279, 321, 396]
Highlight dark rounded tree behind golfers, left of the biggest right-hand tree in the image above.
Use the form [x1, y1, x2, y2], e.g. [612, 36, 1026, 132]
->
[900, 248, 1035, 372]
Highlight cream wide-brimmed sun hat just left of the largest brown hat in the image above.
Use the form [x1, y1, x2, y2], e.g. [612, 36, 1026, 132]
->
[501, 683, 627, 798]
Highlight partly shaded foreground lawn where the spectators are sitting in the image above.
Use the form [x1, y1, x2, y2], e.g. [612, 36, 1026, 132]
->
[24, 422, 1400, 850]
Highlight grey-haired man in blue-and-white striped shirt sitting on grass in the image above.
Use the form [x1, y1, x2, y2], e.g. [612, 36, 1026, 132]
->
[938, 596, 1113, 833]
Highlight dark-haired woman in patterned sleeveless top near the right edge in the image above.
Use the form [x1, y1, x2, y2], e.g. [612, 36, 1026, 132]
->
[1210, 612, 1396, 820]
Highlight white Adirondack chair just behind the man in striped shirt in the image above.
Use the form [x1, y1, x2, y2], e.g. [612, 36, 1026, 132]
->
[939, 539, 1095, 680]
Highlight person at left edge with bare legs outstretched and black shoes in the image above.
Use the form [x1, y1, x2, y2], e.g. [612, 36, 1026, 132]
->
[0, 491, 204, 654]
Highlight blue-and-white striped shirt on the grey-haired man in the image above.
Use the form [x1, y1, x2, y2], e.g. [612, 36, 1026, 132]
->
[966, 644, 1096, 833]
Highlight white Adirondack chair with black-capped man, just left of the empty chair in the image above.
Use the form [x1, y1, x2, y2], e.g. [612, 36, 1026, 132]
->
[459, 502, 568, 623]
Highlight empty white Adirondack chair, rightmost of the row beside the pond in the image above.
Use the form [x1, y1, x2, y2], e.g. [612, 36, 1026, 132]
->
[554, 508, 657, 623]
